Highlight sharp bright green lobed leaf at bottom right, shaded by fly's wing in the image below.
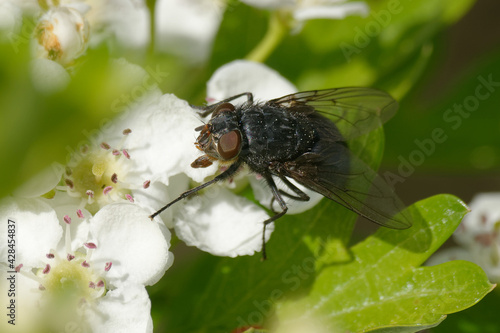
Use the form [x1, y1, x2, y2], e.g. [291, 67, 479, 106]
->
[277, 195, 493, 332]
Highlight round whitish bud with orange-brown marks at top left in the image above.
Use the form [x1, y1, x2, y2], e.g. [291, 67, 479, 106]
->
[32, 6, 89, 66]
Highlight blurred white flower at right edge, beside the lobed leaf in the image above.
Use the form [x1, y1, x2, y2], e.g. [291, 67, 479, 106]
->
[429, 193, 500, 283]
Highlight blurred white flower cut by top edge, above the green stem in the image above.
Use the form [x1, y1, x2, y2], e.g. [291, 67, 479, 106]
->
[241, 0, 369, 22]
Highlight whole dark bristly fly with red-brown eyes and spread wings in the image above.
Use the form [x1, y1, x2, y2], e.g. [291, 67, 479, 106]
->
[150, 88, 411, 259]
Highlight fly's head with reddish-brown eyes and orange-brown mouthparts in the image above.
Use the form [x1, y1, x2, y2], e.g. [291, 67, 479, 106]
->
[191, 103, 242, 168]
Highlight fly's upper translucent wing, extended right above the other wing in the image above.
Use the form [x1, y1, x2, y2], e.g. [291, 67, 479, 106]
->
[267, 87, 398, 139]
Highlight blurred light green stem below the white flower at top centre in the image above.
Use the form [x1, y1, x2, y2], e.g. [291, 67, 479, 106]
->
[245, 11, 288, 62]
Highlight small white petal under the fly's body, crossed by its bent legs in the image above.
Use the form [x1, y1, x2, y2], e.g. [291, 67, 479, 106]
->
[249, 175, 323, 214]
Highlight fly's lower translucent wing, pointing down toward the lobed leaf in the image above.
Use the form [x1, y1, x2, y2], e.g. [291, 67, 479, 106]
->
[285, 142, 411, 229]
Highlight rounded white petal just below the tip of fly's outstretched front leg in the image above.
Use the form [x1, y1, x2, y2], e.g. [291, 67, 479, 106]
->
[90, 203, 173, 285]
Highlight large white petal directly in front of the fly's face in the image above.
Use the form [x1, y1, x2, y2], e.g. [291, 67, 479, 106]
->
[110, 94, 217, 185]
